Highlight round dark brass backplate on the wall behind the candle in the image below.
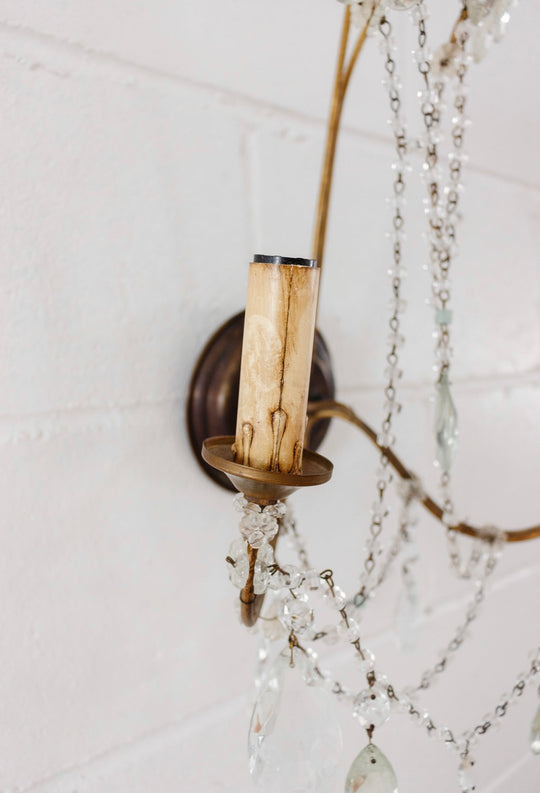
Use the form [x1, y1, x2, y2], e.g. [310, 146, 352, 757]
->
[186, 312, 335, 490]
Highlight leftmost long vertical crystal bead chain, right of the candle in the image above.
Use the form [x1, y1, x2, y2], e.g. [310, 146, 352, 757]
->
[353, 16, 407, 607]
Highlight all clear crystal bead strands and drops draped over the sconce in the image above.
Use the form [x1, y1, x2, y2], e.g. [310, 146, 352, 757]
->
[219, 0, 540, 793]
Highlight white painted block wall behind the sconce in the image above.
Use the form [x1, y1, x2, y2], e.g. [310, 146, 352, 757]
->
[0, 0, 540, 793]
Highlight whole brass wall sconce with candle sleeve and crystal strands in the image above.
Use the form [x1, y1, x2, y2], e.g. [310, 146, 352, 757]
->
[188, 0, 540, 793]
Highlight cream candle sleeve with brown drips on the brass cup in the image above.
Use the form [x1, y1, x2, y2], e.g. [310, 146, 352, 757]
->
[233, 256, 320, 473]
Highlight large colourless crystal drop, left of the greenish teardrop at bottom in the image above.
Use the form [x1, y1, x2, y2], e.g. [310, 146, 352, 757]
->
[248, 652, 342, 793]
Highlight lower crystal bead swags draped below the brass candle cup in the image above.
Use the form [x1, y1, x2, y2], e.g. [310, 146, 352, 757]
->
[228, 495, 540, 791]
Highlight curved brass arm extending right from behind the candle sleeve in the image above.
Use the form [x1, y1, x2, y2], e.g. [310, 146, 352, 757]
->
[306, 400, 540, 542]
